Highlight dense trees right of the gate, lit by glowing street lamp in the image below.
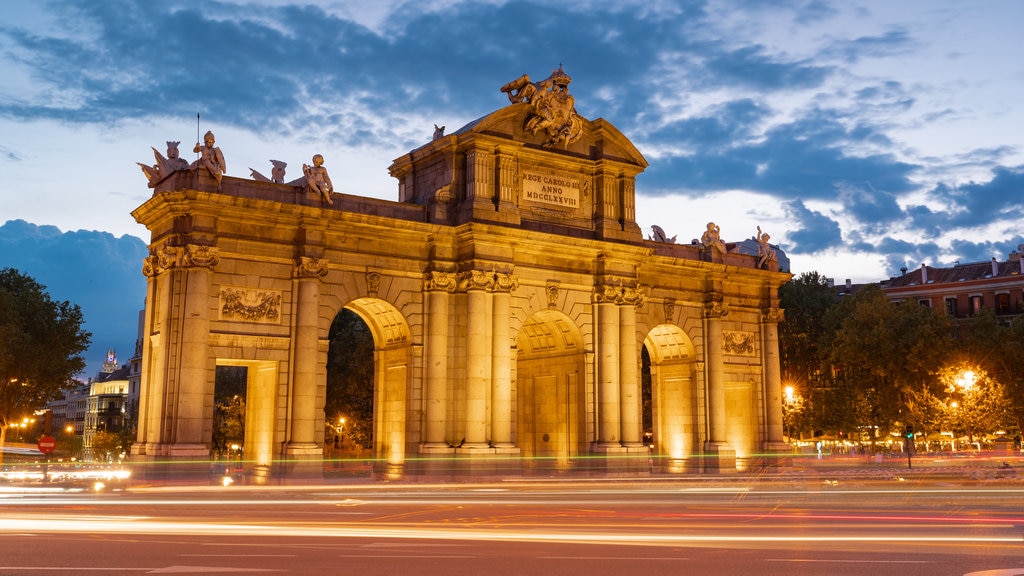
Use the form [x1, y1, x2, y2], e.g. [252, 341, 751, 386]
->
[779, 273, 1011, 442]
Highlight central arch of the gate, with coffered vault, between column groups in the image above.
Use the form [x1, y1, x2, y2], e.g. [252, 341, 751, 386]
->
[516, 311, 587, 470]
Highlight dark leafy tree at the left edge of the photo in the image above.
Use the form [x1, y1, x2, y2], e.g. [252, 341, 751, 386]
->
[0, 269, 92, 461]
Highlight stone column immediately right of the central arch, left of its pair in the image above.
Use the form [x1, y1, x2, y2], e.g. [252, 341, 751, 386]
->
[595, 288, 622, 447]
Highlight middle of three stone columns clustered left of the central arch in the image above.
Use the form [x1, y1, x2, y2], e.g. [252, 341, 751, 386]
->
[463, 271, 492, 449]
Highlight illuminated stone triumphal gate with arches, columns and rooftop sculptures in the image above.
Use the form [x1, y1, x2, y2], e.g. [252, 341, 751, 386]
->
[132, 69, 788, 476]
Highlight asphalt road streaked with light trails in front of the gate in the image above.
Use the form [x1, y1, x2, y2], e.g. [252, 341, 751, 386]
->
[0, 479, 1024, 576]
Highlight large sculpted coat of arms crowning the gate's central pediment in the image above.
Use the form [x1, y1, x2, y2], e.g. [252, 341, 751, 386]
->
[502, 65, 583, 148]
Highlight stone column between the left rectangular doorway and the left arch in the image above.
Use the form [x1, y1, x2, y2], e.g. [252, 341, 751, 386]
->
[285, 256, 328, 455]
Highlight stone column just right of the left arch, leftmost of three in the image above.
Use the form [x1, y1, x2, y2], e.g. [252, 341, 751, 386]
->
[423, 272, 456, 449]
